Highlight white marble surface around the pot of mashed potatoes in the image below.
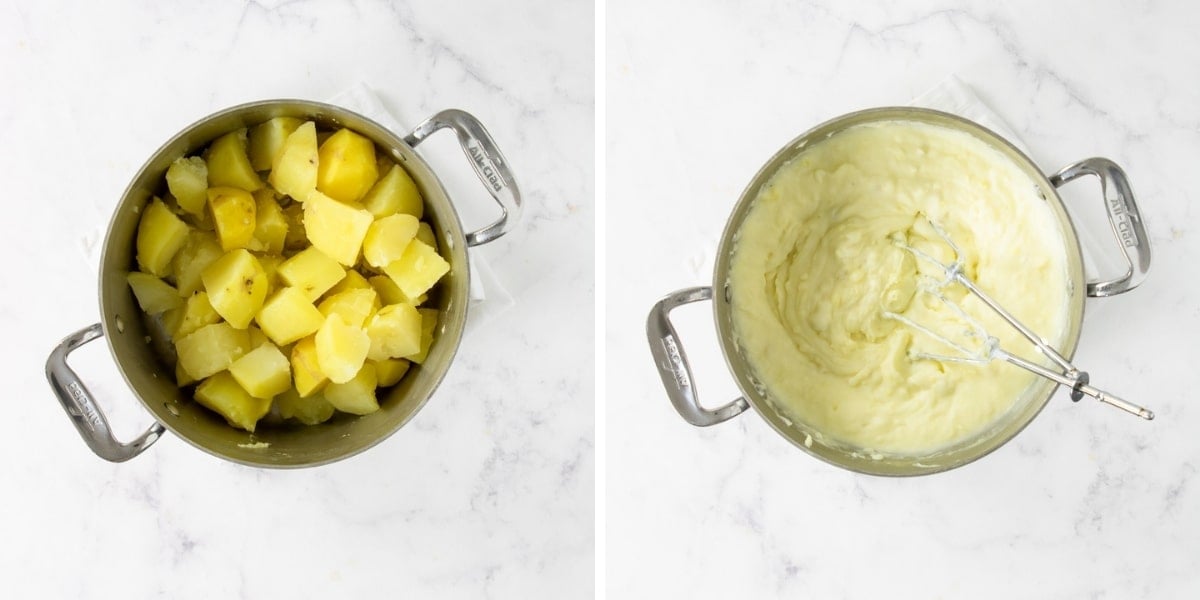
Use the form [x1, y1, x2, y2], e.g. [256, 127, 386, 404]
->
[606, 0, 1200, 599]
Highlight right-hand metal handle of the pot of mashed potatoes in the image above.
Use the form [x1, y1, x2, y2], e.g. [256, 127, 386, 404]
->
[1050, 157, 1150, 298]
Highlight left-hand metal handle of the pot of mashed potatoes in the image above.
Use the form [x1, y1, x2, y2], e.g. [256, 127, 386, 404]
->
[646, 287, 750, 427]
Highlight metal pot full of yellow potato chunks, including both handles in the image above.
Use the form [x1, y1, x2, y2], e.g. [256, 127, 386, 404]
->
[46, 100, 521, 468]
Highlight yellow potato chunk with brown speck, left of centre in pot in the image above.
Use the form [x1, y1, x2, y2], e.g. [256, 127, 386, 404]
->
[200, 248, 266, 329]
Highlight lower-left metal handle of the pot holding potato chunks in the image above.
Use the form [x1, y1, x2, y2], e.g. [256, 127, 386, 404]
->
[46, 323, 163, 462]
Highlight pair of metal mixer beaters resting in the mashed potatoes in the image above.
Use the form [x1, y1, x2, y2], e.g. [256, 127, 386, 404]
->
[883, 215, 1154, 420]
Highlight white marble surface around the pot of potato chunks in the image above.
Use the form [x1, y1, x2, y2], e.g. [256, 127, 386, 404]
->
[0, 0, 594, 599]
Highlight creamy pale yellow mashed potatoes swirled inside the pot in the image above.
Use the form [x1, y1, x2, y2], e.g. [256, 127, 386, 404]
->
[728, 121, 1069, 455]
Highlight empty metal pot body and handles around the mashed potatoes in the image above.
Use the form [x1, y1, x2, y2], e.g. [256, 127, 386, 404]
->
[646, 107, 1150, 475]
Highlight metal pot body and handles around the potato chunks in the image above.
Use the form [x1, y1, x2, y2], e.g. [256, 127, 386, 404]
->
[46, 100, 521, 467]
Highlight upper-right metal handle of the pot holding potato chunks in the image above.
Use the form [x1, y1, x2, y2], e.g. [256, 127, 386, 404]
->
[404, 108, 521, 246]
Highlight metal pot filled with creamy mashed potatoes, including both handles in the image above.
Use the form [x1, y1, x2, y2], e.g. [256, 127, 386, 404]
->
[647, 108, 1150, 475]
